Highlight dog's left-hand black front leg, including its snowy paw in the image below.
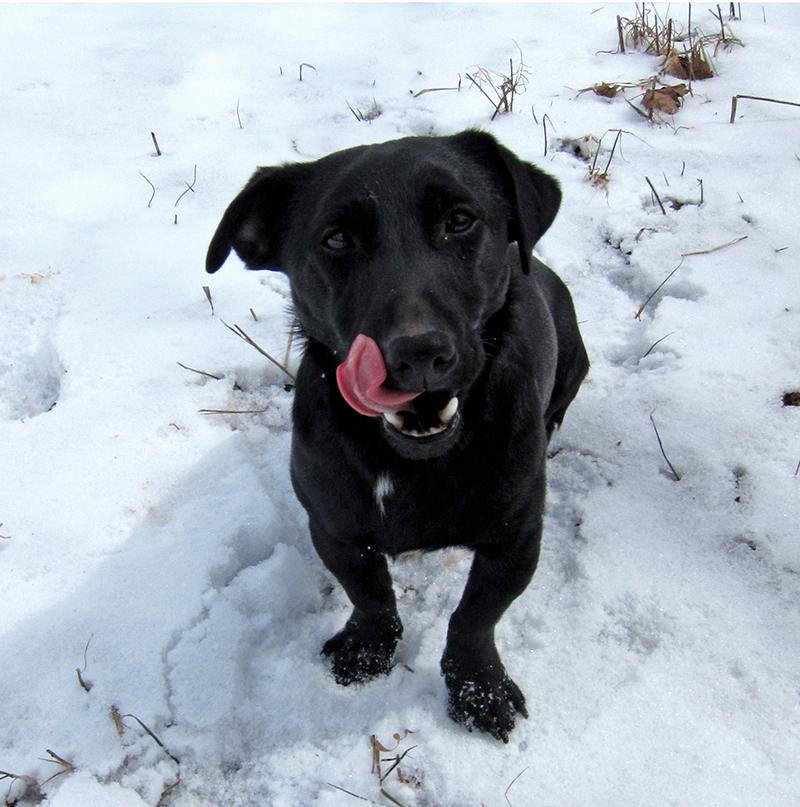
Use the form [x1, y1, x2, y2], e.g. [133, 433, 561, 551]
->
[311, 524, 403, 686]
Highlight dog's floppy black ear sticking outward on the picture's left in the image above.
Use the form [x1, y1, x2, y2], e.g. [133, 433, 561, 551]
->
[206, 164, 304, 273]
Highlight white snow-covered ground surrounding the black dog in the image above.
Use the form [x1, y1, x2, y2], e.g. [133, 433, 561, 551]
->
[0, 3, 800, 807]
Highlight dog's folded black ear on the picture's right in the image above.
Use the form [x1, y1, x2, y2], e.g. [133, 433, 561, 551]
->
[452, 130, 561, 274]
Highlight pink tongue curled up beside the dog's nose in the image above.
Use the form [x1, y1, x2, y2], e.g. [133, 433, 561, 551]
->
[336, 333, 420, 417]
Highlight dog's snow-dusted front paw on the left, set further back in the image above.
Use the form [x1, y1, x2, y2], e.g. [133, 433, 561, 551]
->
[322, 615, 403, 686]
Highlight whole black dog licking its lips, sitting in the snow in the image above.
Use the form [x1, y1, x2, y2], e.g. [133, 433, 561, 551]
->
[206, 131, 589, 742]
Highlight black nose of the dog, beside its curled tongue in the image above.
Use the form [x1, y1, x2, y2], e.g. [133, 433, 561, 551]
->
[383, 331, 456, 390]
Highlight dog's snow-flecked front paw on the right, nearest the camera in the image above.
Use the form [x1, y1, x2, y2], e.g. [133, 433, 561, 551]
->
[442, 656, 528, 743]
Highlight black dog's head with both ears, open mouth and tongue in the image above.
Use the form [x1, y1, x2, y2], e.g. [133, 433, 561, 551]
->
[206, 131, 561, 458]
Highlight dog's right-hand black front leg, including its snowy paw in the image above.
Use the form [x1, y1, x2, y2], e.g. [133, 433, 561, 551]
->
[442, 528, 541, 742]
